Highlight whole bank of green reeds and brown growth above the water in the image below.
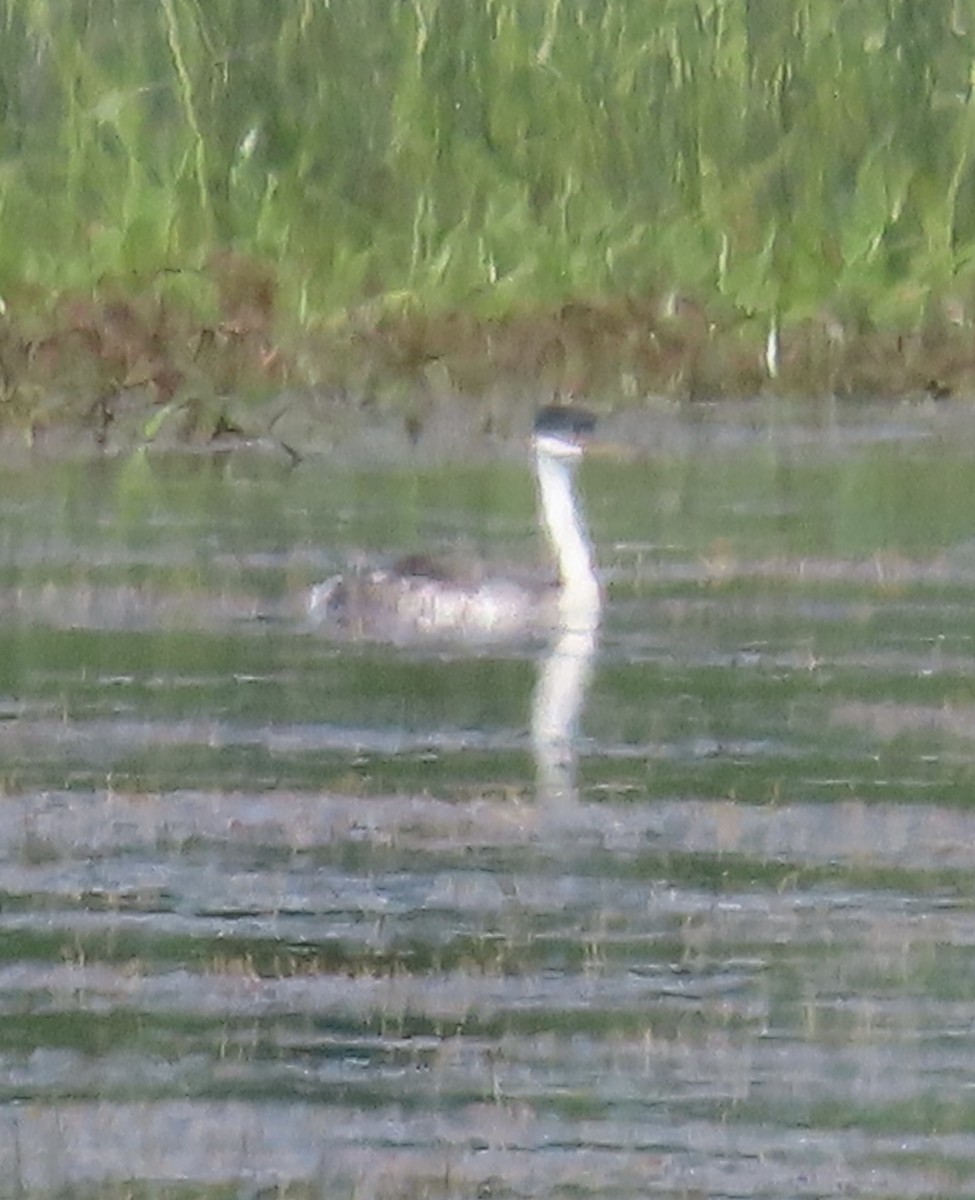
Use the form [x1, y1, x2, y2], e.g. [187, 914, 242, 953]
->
[0, 0, 975, 442]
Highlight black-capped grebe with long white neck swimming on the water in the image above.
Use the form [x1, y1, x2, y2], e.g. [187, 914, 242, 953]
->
[307, 406, 600, 642]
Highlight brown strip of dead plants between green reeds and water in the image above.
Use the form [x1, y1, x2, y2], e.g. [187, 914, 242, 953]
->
[0, 274, 975, 456]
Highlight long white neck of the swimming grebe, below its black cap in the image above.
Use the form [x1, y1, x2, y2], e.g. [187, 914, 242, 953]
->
[536, 451, 599, 614]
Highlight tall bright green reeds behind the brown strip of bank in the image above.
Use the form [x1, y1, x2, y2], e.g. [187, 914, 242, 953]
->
[0, 0, 975, 403]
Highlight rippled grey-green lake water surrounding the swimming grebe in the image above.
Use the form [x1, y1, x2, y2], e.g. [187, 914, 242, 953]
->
[0, 403, 975, 1200]
